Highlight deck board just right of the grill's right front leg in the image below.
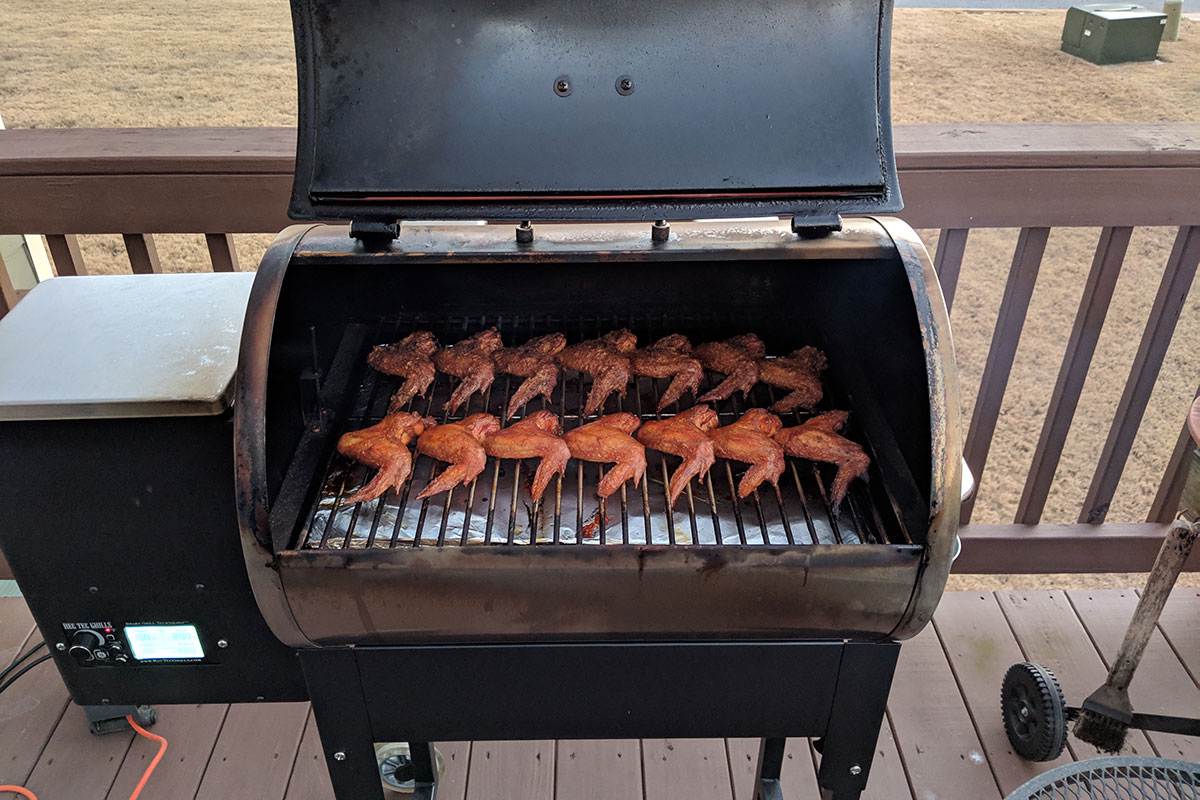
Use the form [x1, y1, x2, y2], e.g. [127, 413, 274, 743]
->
[888, 626, 1001, 800]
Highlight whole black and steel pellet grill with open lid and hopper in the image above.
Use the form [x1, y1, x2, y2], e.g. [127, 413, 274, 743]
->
[0, 0, 961, 800]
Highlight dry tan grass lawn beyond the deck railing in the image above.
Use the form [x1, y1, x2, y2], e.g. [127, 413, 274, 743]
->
[0, 0, 1200, 585]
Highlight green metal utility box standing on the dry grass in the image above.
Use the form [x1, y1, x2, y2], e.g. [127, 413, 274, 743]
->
[1062, 2, 1166, 64]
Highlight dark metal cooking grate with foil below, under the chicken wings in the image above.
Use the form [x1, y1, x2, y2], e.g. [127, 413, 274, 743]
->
[299, 314, 911, 549]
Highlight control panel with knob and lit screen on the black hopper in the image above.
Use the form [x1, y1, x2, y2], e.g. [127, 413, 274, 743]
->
[58, 621, 210, 667]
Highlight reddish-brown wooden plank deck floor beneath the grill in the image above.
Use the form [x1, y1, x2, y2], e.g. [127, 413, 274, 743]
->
[0, 589, 1200, 800]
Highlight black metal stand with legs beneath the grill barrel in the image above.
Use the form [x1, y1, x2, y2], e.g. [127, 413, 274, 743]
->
[300, 640, 900, 800]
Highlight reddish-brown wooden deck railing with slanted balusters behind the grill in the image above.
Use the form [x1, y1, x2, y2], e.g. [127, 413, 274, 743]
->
[0, 124, 1200, 572]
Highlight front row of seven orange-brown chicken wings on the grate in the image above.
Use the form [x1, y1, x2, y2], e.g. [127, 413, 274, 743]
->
[337, 404, 870, 509]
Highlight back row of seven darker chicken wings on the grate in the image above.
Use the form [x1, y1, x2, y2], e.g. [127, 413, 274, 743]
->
[367, 327, 826, 421]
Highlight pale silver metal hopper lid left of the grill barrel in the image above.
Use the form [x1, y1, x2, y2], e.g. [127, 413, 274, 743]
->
[0, 272, 254, 421]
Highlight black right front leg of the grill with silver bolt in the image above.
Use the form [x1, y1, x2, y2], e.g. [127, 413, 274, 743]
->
[817, 642, 900, 800]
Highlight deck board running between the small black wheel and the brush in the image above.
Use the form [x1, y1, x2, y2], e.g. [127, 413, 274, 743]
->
[996, 591, 1154, 759]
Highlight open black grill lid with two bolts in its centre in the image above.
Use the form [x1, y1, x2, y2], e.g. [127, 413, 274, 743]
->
[290, 0, 901, 221]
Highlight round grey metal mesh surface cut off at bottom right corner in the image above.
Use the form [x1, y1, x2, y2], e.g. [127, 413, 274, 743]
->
[1008, 756, 1200, 800]
